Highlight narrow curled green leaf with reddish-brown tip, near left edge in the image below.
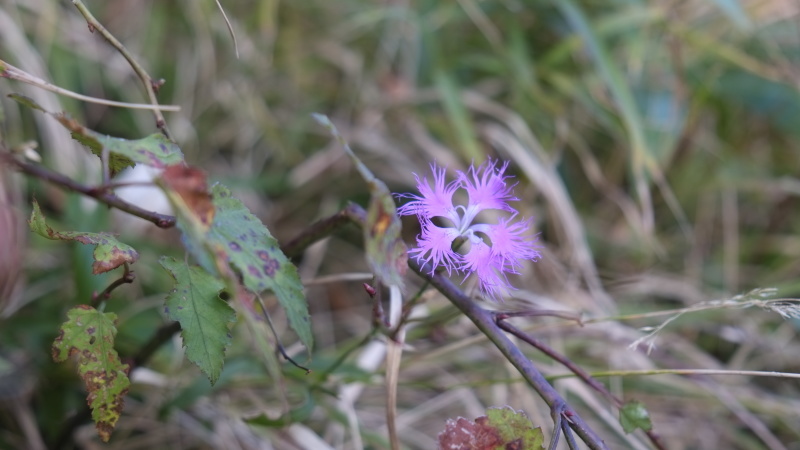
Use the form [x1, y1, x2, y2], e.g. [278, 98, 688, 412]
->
[28, 200, 139, 275]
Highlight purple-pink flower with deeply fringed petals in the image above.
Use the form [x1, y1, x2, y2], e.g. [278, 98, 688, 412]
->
[397, 160, 540, 300]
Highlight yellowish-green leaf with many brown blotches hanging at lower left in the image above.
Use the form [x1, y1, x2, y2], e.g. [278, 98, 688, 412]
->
[52, 305, 130, 442]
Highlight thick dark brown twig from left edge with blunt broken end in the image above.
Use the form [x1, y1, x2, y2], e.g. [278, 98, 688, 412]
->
[0, 151, 175, 228]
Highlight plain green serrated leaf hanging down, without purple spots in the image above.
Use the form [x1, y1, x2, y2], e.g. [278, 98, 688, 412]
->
[158, 256, 236, 384]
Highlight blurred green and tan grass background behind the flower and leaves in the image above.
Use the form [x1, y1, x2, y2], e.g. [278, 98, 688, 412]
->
[0, 0, 800, 449]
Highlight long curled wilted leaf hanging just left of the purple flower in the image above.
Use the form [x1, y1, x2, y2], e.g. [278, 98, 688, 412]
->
[313, 114, 408, 287]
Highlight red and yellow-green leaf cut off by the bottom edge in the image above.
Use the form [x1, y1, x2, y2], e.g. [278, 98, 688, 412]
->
[439, 407, 544, 450]
